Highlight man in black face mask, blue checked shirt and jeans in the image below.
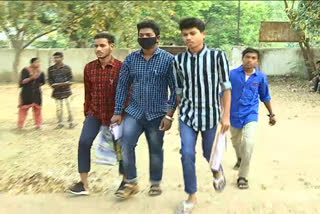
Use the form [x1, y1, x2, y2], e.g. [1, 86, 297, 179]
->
[111, 20, 176, 199]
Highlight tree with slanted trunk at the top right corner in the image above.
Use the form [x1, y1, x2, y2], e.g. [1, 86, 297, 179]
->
[284, 0, 320, 80]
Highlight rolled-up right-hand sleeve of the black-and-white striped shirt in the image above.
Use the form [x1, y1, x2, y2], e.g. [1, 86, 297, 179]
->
[218, 52, 232, 91]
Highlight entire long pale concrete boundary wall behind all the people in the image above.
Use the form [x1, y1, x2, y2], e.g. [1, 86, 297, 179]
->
[0, 47, 320, 82]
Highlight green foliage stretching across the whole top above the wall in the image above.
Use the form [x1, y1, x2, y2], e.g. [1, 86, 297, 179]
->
[0, 0, 320, 49]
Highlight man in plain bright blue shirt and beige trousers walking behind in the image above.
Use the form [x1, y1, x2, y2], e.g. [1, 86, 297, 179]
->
[230, 48, 276, 189]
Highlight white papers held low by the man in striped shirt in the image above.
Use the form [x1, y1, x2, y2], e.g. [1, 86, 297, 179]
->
[209, 131, 227, 171]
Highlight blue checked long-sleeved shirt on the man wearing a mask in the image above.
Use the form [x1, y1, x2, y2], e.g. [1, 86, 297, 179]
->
[114, 48, 177, 120]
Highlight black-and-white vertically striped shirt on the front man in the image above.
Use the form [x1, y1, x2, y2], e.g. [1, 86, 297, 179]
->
[173, 46, 231, 131]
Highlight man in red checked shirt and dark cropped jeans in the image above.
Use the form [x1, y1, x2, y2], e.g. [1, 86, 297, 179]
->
[69, 33, 123, 195]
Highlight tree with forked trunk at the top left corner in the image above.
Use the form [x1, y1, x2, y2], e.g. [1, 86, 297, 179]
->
[0, 1, 65, 79]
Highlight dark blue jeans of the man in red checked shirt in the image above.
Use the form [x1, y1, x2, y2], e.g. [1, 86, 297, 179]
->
[78, 115, 123, 174]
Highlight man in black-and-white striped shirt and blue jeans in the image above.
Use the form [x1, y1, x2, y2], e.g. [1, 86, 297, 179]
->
[173, 18, 231, 213]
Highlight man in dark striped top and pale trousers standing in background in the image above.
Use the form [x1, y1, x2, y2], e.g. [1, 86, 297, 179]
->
[48, 52, 75, 129]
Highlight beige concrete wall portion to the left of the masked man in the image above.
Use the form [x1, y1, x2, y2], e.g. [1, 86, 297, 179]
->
[0, 48, 131, 82]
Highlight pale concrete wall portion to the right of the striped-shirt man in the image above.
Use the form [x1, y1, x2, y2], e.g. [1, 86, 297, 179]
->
[230, 47, 320, 77]
